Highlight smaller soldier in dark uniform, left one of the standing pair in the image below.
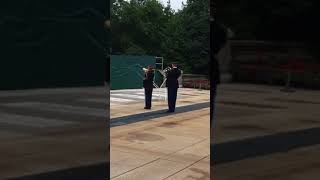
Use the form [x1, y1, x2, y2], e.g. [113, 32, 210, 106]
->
[143, 65, 154, 109]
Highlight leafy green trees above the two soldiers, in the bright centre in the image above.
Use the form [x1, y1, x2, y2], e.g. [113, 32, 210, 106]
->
[111, 0, 210, 74]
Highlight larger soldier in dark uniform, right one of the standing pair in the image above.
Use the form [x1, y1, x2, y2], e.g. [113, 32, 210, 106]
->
[166, 63, 181, 113]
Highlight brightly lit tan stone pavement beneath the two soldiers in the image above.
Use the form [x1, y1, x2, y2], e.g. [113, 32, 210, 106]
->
[110, 88, 210, 180]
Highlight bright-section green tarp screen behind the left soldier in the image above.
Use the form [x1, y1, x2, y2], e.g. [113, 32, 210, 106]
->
[110, 55, 156, 89]
